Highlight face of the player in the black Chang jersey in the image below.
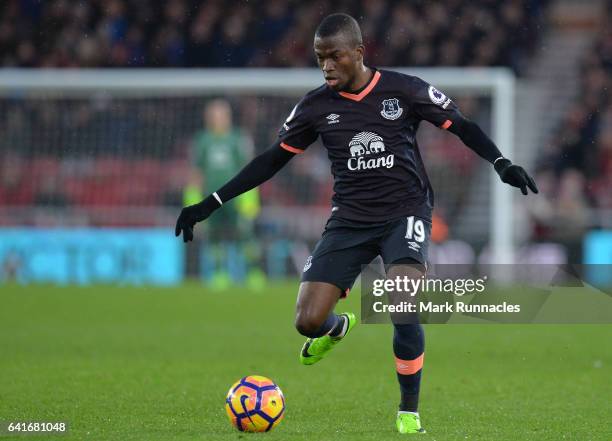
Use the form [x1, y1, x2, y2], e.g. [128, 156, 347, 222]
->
[314, 35, 363, 91]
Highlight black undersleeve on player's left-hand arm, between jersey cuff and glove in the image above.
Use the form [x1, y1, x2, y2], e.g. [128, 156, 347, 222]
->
[217, 142, 295, 202]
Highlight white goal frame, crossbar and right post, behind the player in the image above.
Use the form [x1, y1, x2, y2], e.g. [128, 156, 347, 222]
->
[0, 68, 515, 263]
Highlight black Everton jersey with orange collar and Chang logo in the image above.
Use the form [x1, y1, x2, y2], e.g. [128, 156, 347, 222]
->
[279, 70, 461, 222]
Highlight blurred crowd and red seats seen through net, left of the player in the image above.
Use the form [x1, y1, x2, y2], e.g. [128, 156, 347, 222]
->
[0, 95, 330, 225]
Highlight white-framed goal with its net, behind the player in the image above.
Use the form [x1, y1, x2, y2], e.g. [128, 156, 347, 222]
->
[0, 68, 514, 276]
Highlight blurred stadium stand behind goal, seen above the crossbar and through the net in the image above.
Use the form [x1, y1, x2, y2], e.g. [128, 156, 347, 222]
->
[0, 0, 548, 241]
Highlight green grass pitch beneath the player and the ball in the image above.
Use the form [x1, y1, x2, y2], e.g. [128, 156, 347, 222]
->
[0, 283, 612, 441]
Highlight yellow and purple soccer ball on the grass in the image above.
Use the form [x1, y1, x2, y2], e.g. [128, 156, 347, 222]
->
[225, 375, 285, 432]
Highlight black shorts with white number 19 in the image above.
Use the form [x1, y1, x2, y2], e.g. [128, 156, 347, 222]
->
[302, 216, 431, 296]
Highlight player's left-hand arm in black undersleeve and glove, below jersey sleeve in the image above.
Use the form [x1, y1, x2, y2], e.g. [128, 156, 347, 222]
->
[174, 142, 296, 242]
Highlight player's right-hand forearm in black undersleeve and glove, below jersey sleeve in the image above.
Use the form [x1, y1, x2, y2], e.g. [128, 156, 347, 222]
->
[448, 112, 538, 195]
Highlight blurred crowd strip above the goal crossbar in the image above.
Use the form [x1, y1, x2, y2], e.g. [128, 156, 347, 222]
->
[0, 0, 548, 71]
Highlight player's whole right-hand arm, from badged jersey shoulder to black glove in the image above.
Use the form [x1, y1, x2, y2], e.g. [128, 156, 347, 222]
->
[407, 77, 538, 195]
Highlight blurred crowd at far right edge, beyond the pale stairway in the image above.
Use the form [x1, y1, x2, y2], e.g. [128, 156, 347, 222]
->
[531, 1, 612, 248]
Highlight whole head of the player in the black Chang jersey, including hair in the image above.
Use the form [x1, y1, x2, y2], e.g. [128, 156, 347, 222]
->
[314, 14, 365, 90]
